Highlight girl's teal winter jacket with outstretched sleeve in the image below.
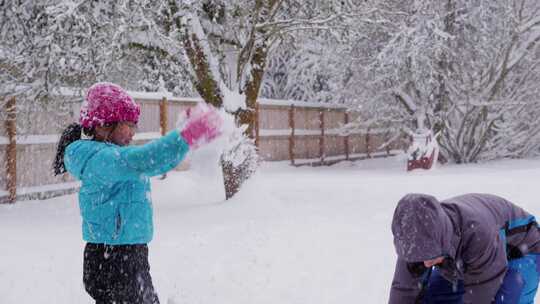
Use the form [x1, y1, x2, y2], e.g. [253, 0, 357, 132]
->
[64, 131, 189, 245]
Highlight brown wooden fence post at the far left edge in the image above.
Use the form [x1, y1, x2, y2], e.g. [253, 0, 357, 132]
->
[5, 97, 17, 203]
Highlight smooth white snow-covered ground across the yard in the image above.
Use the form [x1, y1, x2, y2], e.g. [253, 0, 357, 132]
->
[0, 157, 540, 304]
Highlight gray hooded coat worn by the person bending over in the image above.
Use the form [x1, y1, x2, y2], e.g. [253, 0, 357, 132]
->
[389, 194, 540, 304]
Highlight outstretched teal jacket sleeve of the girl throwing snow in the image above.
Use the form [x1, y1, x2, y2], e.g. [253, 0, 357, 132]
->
[91, 130, 189, 182]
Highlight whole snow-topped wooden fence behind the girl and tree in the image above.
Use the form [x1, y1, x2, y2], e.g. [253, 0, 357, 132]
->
[0, 92, 403, 203]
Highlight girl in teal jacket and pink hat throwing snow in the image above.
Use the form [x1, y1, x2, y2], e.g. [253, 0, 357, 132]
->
[54, 83, 221, 304]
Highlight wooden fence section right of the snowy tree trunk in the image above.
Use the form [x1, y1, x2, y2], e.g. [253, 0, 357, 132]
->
[255, 99, 403, 165]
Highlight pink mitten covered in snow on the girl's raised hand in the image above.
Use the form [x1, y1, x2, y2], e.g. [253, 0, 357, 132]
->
[180, 107, 223, 148]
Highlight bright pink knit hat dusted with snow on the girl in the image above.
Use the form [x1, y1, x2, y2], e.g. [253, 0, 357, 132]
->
[80, 82, 141, 128]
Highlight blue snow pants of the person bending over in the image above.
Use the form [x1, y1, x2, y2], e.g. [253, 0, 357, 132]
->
[422, 254, 540, 304]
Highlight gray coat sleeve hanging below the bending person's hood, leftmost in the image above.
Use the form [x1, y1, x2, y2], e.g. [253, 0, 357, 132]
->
[388, 258, 422, 304]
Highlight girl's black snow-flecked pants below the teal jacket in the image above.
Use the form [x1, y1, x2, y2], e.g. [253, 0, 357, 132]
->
[83, 243, 159, 304]
